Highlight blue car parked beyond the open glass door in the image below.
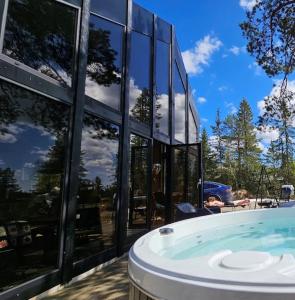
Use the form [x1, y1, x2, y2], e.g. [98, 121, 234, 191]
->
[204, 181, 233, 204]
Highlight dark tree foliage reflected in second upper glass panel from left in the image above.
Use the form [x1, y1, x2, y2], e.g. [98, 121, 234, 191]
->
[87, 23, 121, 86]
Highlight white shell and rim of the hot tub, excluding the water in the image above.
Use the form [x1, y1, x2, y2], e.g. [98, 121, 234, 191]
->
[128, 208, 295, 300]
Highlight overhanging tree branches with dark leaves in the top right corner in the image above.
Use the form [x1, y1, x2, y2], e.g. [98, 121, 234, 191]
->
[240, 0, 295, 77]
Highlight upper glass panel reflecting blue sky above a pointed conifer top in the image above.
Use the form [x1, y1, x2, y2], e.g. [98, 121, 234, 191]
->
[129, 32, 152, 124]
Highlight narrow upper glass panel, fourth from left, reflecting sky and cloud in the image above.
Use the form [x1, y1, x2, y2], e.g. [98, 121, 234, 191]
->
[155, 41, 170, 135]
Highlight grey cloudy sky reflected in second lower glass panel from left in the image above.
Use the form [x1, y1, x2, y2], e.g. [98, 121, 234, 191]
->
[81, 118, 119, 187]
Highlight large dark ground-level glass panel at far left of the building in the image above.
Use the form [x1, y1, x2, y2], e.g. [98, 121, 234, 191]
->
[0, 81, 69, 292]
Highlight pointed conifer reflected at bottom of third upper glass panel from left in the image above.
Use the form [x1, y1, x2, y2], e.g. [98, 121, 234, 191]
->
[131, 88, 151, 124]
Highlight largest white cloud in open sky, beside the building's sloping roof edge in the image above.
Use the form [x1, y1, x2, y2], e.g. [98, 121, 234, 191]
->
[182, 35, 222, 75]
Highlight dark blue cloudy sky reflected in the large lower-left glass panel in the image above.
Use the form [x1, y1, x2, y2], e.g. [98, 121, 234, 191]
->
[0, 122, 55, 192]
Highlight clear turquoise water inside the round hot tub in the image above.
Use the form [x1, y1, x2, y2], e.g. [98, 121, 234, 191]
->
[160, 216, 295, 260]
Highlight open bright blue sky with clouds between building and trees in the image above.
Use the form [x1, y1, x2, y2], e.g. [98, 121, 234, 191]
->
[136, 0, 295, 150]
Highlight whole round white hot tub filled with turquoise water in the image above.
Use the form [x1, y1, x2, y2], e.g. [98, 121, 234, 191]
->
[128, 208, 295, 300]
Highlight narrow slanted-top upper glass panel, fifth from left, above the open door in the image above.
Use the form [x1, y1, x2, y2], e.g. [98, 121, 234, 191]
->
[174, 64, 185, 143]
